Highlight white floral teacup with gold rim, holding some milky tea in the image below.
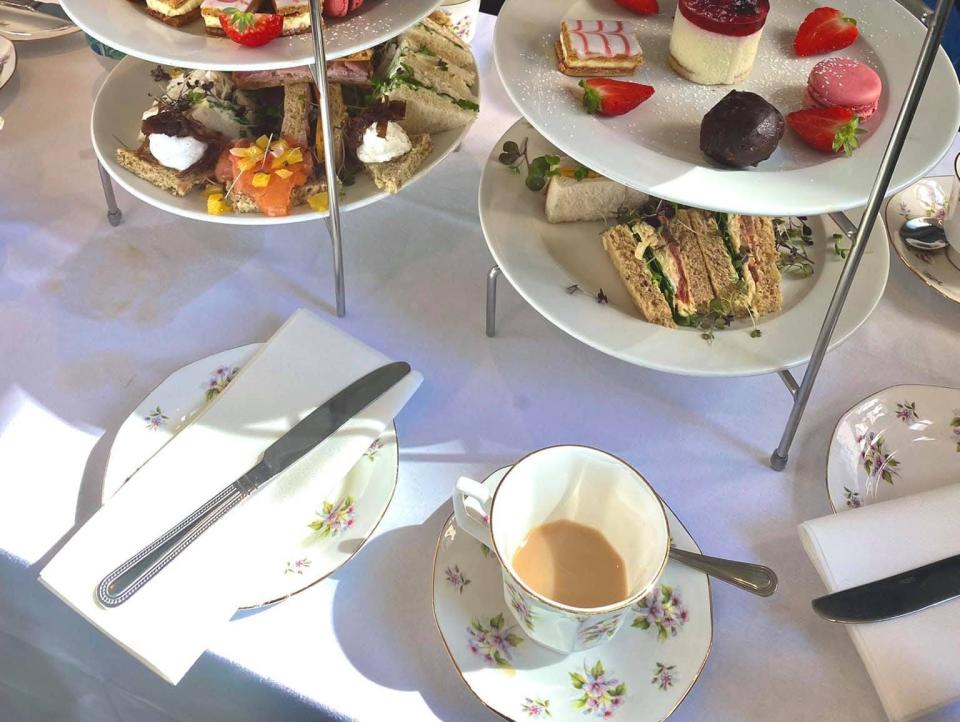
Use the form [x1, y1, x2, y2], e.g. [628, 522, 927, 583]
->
[453, 446, 670, 653]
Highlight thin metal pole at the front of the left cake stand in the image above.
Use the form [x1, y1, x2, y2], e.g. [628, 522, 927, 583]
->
[310, 0, 347, 317]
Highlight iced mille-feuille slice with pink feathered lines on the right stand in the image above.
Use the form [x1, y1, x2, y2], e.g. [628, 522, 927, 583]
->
[556, 20, 643, 77]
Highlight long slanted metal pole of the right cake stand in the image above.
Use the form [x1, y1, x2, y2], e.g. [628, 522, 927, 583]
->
[770, 0, 953, 471]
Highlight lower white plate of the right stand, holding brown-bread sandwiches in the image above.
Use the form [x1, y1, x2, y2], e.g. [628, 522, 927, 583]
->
[479, 120, 890, 376]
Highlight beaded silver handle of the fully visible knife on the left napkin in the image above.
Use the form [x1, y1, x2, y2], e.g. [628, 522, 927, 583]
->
[97, 482, 249, 607]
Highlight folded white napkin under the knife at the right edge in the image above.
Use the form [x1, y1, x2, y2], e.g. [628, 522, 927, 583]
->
[800, 484, 960, 722]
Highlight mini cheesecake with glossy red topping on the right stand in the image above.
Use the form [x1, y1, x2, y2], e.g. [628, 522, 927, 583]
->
[670, 0, 770, 85]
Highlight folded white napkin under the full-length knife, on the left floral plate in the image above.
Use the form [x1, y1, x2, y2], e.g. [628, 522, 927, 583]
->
[40, 310, 423, 684]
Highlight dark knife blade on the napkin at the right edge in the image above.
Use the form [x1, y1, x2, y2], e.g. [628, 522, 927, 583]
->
[813, 554, 960, 624]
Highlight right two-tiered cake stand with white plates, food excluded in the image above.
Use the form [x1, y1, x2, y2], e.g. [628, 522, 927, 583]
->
[488, 0, 960, 471]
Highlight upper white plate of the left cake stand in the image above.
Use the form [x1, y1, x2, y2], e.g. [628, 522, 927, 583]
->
[63, 0, 440, 70]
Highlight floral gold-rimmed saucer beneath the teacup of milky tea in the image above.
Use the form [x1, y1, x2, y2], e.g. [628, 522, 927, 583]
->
[433, 468, 713, 722]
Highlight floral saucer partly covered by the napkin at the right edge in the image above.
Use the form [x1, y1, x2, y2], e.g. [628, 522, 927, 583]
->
[827, 386, 960, 512]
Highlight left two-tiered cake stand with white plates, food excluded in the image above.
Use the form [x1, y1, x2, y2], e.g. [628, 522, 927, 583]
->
[63, 0, 454, 316]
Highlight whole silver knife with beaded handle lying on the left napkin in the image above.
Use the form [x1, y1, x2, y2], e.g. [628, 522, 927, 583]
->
[97, 361, 410, 607]
